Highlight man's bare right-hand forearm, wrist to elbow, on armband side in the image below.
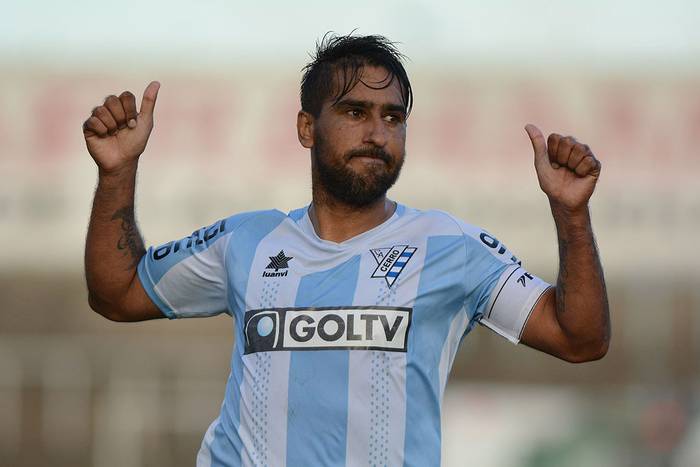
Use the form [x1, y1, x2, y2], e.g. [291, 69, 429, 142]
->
[551, 204, 610, 356]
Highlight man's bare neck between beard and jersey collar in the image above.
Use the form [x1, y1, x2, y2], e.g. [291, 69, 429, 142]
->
[309, 196, 396, 243]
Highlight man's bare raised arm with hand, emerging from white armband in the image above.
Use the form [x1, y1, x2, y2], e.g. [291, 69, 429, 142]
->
[522, 125, 610, 362]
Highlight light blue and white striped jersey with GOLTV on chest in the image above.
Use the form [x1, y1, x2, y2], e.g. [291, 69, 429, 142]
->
[138, 204, 548, 467]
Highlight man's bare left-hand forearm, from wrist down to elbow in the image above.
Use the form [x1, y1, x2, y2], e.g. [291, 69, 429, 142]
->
[85, 164, 145, 311]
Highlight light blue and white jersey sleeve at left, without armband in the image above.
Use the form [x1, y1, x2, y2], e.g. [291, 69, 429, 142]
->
[137, 216, 236, 319]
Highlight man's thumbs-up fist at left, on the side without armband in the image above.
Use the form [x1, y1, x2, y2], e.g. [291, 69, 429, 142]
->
[83, 81, 160, 173]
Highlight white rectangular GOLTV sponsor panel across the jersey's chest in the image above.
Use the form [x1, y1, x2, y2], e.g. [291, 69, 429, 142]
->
[243, 306, 412, 354]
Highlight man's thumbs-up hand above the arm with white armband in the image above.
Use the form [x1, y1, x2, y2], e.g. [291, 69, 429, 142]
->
[525, 124, 600, 211]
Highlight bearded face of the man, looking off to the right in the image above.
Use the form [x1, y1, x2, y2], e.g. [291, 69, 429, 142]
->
[311, 66, 406, 207]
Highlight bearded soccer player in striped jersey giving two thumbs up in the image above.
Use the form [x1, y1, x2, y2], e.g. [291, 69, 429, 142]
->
[83, 35, 610, 467]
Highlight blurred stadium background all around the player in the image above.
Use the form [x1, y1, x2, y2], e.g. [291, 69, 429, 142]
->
[0, 0, 700, 467]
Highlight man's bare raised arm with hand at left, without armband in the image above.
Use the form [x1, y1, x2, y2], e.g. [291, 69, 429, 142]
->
[83, 81, 163, 321]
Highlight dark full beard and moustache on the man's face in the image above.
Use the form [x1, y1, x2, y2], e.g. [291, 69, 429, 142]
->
[311, 129, 403, 208]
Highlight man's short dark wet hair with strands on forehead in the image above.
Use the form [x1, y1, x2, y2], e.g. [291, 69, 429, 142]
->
[300, 32, 413, 117]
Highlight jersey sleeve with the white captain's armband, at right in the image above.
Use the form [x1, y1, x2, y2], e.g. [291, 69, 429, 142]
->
[465, 226, 551, 344]
